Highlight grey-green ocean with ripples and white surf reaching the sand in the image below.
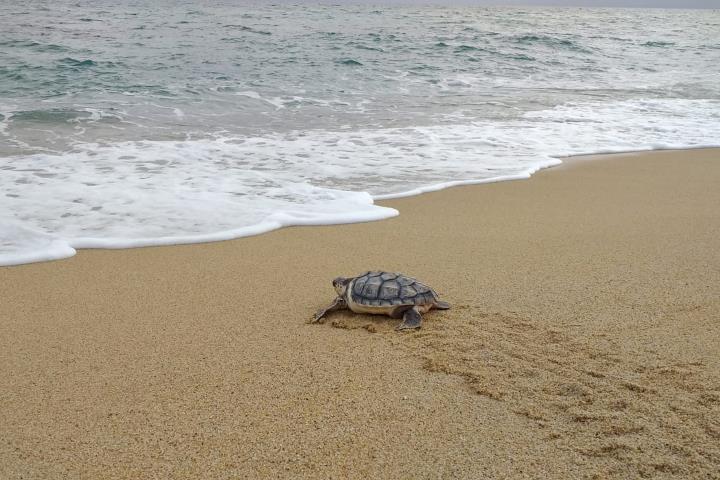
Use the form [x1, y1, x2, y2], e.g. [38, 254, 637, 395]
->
[0, 0, 720, 265]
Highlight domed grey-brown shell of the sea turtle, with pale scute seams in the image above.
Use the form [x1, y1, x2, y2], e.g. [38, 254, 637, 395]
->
[349, 272, 438, 307]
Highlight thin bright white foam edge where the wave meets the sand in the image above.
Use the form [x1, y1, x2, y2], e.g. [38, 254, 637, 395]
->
[0, 146, 720, 268]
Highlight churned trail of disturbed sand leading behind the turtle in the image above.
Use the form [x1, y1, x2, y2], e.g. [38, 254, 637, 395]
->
[332, 305, 720, 478]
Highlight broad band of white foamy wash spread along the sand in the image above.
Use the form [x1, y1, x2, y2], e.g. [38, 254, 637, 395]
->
[0, 100, 720, 265]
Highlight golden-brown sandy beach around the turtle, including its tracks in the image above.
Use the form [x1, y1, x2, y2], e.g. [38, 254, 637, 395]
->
[0, 150, 720, 479]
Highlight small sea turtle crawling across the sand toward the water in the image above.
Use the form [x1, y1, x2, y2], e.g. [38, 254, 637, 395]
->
[312, 272, 450, 330]
